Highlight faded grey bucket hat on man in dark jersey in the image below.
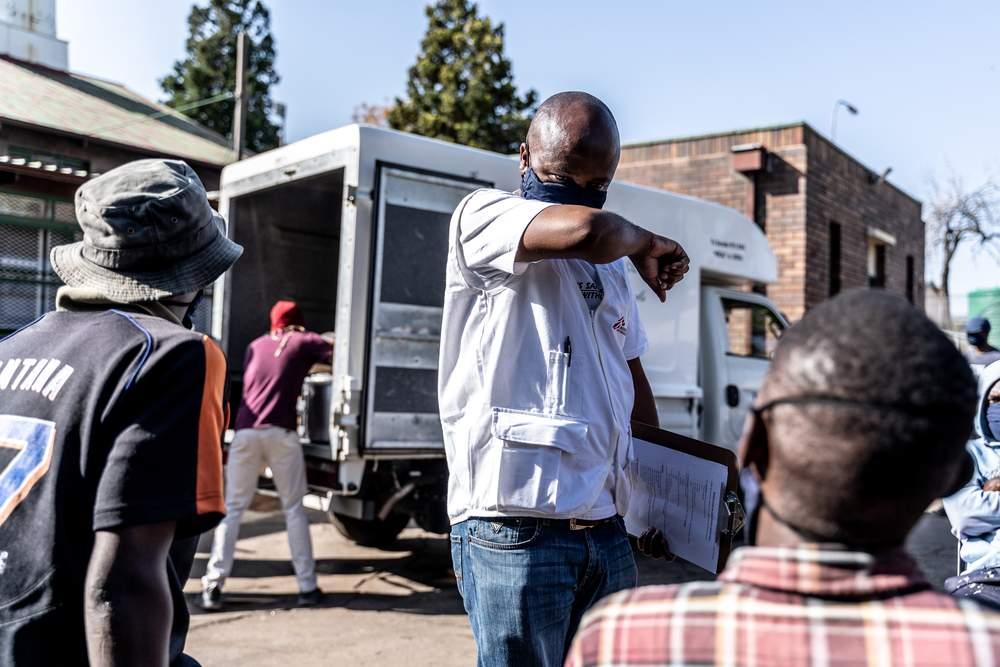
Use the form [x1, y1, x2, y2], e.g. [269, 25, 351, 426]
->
[50, 159, 243, 303]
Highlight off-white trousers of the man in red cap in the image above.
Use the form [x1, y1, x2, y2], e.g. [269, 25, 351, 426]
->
[201, 426, 316, 593]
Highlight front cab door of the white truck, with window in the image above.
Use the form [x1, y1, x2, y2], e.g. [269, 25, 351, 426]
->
[702, 288, 787, 450]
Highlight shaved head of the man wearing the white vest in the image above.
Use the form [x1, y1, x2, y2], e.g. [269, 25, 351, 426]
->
[521, 91, 621, 189]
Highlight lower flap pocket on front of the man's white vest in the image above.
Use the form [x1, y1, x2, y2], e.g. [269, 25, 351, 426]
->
[491, 408, 589, 513]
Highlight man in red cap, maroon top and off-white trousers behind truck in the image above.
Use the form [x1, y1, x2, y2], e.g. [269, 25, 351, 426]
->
[201, 301, 333, 610]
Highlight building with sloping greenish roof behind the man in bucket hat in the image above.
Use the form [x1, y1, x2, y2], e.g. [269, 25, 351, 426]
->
[0, 0, 234, 334]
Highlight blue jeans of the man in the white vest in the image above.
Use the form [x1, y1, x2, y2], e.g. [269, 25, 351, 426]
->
[451, 518, 637, 667]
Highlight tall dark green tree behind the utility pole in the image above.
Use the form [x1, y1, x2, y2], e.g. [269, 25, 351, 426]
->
[160, 0, 279, 152]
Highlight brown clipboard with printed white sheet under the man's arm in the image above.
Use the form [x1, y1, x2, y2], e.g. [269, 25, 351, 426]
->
[625, 422, 744, 573]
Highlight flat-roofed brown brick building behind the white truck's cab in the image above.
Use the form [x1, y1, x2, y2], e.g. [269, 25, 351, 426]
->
[617, 123, 924, 320]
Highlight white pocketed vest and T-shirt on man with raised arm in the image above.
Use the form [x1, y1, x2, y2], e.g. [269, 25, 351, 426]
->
[438, 190, 647, 522]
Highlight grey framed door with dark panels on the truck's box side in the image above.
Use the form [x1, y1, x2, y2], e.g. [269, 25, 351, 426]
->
[363, 166, 487, 455]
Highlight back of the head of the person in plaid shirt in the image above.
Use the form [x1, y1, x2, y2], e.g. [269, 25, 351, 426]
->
[743, 290, 976, 546]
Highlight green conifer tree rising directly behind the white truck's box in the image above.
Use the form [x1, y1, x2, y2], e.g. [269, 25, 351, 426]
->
[388, 0, 538, 153]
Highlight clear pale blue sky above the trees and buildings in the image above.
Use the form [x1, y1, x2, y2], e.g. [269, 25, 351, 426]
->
[57, 0, 1000, 313]
